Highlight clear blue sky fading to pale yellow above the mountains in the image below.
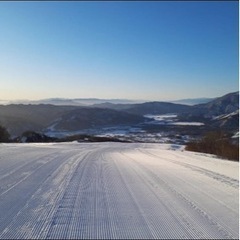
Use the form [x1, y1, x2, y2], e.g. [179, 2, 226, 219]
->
[0, 1, 239, 100]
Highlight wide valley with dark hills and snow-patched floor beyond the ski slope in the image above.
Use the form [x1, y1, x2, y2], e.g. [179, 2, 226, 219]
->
[0, 92, 239, 144]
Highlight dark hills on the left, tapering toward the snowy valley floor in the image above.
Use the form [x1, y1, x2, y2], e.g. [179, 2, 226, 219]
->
[0, 104, 144, 136]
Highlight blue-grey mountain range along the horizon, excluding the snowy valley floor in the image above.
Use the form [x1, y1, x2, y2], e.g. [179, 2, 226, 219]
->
[0, 92, 239, 136]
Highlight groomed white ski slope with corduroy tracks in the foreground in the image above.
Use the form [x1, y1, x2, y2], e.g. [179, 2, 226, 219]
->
[0, 143, 239, 239]
